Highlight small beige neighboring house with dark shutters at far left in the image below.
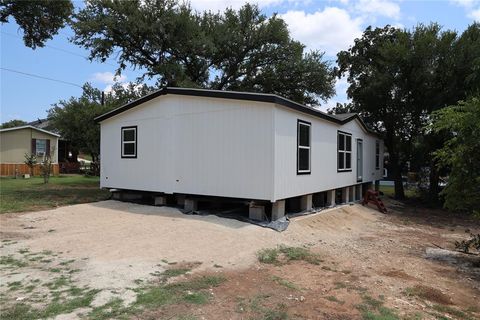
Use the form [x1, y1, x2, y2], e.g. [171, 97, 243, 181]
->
[0, 125, 60, 176]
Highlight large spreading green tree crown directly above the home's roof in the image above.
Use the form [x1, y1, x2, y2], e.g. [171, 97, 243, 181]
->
[72, 0, 334, 104]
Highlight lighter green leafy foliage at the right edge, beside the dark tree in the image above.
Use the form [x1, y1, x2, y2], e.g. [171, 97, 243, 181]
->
[432, 96, 480, 213]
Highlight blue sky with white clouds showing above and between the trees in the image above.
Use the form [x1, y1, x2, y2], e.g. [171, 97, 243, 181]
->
[0, 0, 480, 122]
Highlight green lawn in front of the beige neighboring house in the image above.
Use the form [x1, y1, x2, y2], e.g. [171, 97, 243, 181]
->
[0, 175, 110, 213]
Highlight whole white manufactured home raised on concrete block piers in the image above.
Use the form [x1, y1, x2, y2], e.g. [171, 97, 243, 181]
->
[96, 87, 384, 220]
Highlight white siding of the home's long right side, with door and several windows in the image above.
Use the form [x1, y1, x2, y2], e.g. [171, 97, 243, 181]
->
[272, 105, 383, 201]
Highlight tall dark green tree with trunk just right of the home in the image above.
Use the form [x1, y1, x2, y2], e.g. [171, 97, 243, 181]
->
[337, 23, 480, 198]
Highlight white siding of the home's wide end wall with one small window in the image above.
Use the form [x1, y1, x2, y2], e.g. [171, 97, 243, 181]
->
[101, 95, 274, 200]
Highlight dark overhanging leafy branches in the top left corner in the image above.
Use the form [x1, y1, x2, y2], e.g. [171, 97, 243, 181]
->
[0, 0, 73, 49]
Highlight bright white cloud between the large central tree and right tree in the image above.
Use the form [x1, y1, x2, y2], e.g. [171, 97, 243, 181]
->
[280, 7, 362, 56]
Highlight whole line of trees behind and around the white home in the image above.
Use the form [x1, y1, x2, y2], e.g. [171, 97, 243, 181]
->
[0, 0, 480, 215]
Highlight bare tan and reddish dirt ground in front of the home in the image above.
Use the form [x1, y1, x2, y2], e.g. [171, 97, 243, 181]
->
[0, 200, 480, 319]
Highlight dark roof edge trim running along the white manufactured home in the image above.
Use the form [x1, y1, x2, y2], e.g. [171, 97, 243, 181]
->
[95, 87, 379, 136]
